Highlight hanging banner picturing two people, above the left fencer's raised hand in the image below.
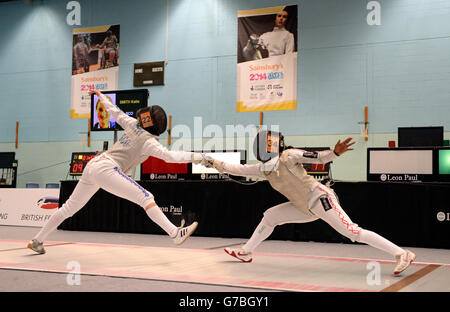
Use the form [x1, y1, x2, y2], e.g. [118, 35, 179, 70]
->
[70, 25, 120, 118]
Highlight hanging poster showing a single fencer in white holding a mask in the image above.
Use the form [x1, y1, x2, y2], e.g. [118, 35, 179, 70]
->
[236, 5, 298, 112]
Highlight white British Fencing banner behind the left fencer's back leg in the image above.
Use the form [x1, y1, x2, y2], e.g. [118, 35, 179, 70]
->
[0, 188, 59, 227]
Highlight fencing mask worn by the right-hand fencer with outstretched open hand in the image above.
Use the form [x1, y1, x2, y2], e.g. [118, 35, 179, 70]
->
[253, 130, 284, 162]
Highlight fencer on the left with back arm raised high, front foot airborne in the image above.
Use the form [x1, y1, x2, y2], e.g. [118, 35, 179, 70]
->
[27, 90, 203, 254]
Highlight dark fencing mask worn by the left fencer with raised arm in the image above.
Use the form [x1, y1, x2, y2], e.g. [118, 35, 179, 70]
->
[136, 105, 167, 136]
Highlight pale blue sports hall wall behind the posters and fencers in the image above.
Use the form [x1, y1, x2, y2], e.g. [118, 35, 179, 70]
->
[0, 0, 450, 187]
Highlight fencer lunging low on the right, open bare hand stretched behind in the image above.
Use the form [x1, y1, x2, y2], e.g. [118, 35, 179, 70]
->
[204, 131, 415, 274]
